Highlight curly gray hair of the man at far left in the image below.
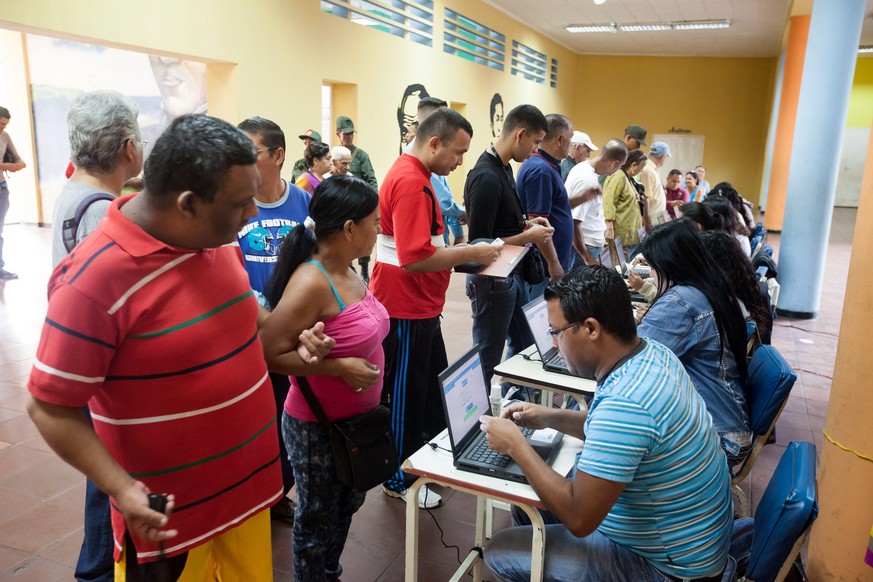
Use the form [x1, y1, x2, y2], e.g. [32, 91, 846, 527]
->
[67, 91, 140, 174]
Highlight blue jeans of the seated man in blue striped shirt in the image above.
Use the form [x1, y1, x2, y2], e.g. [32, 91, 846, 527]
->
[485, 508, 671, 582]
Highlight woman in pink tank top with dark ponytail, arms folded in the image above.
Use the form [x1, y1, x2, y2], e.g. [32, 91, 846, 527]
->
[260, 175, 389, 581]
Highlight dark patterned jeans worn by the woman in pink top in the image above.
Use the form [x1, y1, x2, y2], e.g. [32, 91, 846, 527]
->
[282, 413, 366, 582]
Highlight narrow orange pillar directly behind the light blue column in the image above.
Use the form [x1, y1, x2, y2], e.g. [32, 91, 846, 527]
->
[764, 15, 810, 231]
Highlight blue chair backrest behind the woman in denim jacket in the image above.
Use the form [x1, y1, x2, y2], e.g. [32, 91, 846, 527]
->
[746, 345, 797, 434]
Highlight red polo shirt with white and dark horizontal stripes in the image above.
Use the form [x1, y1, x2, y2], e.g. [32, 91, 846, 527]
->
[28, 196, 282, 562]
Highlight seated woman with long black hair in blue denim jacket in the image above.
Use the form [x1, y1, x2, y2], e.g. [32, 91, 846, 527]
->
[638, 218, 752, 466]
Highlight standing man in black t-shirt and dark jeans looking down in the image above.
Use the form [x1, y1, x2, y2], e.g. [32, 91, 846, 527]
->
[464, 105, 564, 383]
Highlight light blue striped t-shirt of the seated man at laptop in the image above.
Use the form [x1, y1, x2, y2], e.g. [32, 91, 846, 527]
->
[577, 340, 733, 578]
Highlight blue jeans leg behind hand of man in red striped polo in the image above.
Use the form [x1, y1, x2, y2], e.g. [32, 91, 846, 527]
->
[74, 407, 115, 582]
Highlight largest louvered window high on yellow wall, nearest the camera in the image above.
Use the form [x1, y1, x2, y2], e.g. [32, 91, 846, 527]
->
[320, 0, 433, 46]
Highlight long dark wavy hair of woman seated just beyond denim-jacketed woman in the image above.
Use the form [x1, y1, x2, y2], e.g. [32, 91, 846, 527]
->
[701, 230, 773, 344]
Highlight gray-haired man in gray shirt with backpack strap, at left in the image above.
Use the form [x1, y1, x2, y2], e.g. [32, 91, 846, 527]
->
[52, 91, 146, 267]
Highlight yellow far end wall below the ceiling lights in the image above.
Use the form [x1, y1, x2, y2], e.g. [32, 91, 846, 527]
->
[573, 55, 777, 202]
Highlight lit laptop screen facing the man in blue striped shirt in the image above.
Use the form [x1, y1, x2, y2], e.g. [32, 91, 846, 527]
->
[440, 346, 491, 447]
